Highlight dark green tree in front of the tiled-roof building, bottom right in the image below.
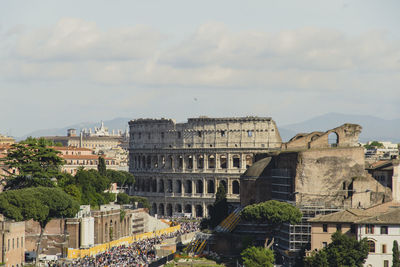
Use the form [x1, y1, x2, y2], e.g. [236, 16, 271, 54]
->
[305, 231, 368, 267]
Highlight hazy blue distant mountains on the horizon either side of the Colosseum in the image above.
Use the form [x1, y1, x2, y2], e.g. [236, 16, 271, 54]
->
[17, 113, 400, 143]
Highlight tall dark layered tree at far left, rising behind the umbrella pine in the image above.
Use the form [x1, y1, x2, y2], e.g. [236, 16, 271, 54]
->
[2, 138, 64, 190]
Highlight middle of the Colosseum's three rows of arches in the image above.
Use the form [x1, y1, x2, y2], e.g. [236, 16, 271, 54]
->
[135, 178, 240, 194]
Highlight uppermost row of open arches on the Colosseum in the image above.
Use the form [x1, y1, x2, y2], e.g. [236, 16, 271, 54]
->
[130, 153, 253, 170]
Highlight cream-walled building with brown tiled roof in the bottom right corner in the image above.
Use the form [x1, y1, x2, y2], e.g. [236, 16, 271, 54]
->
[309, 202, 400, 267]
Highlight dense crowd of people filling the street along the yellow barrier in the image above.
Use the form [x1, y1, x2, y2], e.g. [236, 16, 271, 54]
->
[49, 222, 199, 267]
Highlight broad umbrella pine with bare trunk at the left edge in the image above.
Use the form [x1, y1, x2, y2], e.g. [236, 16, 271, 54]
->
[0, 187, 79, 262]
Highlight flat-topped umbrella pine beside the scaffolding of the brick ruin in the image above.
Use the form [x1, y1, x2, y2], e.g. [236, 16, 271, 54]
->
[241, 200, 302, 248]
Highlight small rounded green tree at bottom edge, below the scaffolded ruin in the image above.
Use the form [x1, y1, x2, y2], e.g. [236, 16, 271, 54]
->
[240, 247, 275, 267]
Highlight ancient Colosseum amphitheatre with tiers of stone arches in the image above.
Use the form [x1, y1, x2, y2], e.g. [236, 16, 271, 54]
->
[129, 117, 282, 217]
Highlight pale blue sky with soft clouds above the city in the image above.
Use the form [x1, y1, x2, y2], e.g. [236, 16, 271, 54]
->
[0, 0, 400, 136]
